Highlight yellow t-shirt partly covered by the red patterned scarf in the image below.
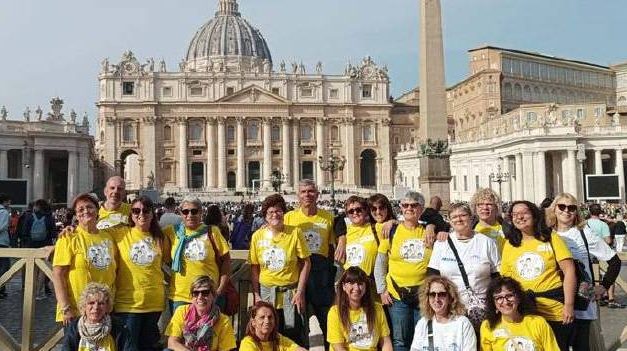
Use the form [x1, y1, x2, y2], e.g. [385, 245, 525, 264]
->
[164, 305, 236, 351]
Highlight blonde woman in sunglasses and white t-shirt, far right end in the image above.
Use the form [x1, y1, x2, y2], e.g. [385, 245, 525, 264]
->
[546, 193, 621, 351]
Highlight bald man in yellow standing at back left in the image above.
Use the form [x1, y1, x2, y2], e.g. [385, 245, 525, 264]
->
[97, 176, 131, 229]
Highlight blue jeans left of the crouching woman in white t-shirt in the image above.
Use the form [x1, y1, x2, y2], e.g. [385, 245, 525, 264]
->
[388, 298, 420, 351]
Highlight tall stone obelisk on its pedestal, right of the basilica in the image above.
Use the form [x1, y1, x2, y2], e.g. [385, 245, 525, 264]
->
[418, 0, 451, 208]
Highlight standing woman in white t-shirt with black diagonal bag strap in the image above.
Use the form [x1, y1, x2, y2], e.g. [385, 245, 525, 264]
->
[429, 203, 501, 331]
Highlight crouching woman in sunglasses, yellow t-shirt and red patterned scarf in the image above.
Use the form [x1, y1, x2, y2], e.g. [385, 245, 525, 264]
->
[164, 275, 236, 351]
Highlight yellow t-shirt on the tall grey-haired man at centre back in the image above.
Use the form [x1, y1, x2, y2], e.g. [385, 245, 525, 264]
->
[283, 208, 335, 257]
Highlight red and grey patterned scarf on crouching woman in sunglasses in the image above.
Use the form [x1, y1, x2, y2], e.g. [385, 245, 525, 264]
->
[183, 303, 220, 351]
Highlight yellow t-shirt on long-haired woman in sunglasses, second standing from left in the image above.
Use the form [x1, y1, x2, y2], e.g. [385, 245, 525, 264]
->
[110, 226, 172, 313]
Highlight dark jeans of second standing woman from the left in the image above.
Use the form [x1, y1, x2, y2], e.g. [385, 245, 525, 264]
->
[114, 312, 161, 351]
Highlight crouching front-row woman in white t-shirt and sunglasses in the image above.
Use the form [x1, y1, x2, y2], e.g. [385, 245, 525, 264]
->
[411, 276, 477, 351]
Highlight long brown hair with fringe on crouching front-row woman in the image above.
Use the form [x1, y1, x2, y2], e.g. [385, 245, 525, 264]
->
[335, 266, 376, 333]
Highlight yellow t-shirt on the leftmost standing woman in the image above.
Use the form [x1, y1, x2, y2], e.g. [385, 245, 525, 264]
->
[52, 226, 118, 322]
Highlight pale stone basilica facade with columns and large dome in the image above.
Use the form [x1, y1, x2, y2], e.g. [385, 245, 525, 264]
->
[96, 0, 404, 193]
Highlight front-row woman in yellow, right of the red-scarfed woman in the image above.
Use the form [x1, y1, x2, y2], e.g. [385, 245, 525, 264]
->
[239, 301, 306, 351]
